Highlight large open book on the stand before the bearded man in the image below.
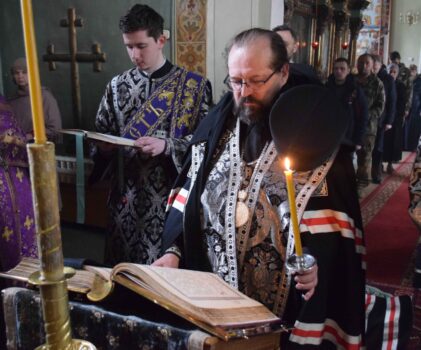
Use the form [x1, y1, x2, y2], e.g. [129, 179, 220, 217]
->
[0, 258, 280, 340]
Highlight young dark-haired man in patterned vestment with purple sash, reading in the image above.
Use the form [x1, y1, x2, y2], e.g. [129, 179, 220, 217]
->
[94, 4, 212, 265]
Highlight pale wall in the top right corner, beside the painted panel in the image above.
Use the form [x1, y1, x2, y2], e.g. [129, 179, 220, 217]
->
[389, 0, 421, 71]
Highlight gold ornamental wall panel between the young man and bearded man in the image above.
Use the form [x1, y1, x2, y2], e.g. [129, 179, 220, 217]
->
[175, 0, 207, 76]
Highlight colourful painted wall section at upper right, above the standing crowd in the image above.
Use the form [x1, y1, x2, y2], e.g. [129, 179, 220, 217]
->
[357, 0, 390, 57]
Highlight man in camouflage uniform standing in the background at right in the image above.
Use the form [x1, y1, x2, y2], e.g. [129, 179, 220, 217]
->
[356, 54, 385, 192]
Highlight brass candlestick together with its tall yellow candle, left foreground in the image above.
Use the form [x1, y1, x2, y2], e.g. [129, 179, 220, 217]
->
[21, 0, 95, 350]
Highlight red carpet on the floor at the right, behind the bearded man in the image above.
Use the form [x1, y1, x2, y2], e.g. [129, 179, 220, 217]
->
[361, 154, 419, 285]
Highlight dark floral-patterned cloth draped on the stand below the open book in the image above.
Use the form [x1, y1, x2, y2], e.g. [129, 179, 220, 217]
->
[2, 287, 210, 350]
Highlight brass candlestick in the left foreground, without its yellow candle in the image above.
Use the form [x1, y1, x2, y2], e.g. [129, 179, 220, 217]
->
[27, 142, 96, 350]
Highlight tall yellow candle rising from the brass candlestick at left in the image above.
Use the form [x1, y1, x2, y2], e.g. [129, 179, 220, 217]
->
[21, 0, 47, 144]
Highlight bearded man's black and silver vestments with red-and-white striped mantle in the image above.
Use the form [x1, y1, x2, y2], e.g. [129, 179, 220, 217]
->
[163, 94, 365, 349]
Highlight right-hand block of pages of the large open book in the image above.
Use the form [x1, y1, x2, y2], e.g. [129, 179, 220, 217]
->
[113, 263, 279, 326]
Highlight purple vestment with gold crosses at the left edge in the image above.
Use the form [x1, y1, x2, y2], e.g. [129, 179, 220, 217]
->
[0, 95, 37, 271]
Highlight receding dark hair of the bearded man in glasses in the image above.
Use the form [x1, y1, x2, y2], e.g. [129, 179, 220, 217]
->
[227, 28, 289, 71]
